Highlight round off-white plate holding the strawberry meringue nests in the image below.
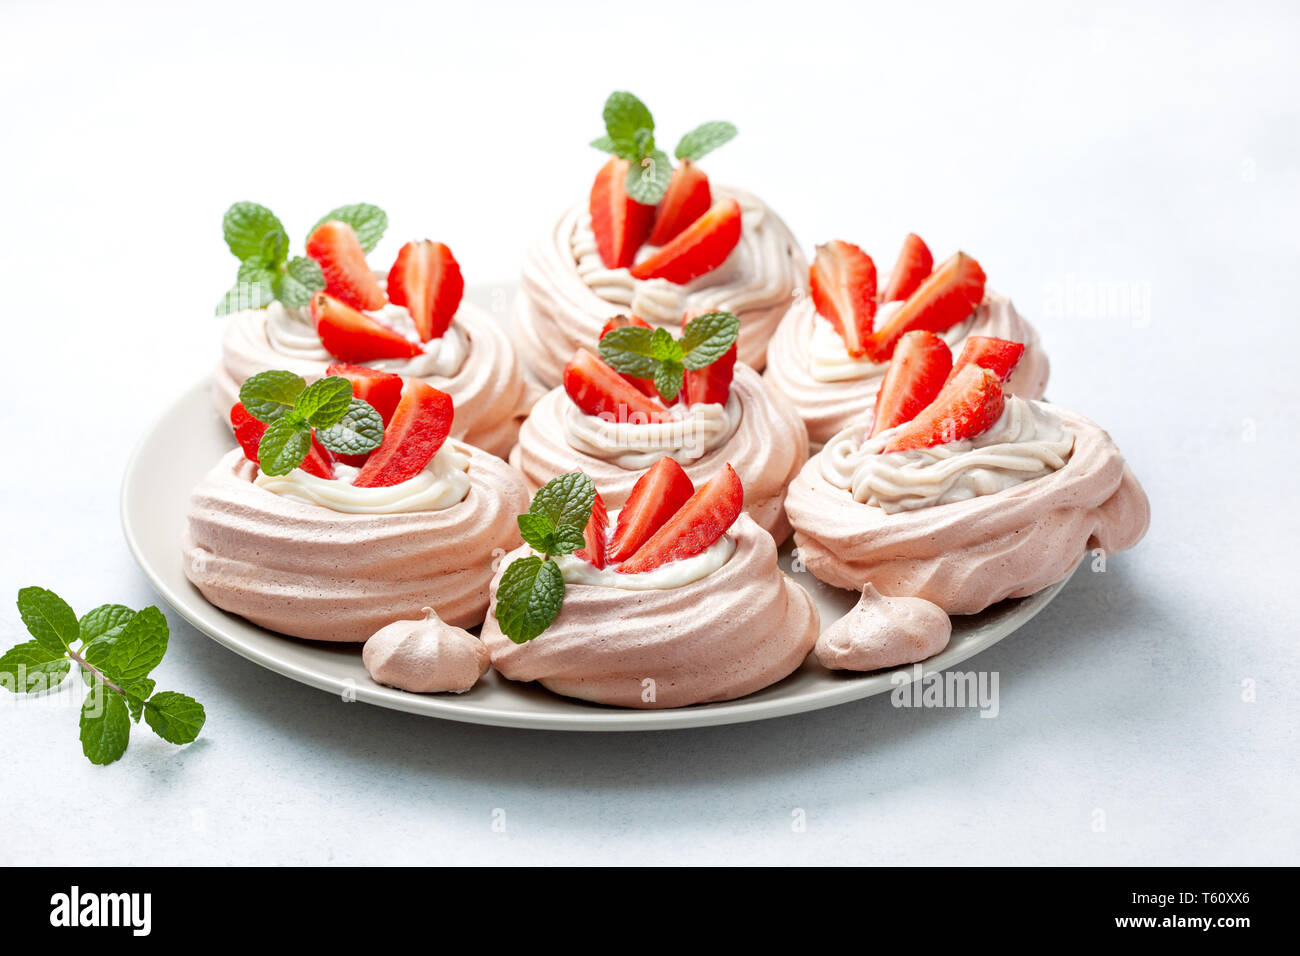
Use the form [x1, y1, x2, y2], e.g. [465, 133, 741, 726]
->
[122, 285, 1065, 731]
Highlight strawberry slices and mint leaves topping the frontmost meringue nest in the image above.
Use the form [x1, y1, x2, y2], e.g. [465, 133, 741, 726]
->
[495, 458, 745, 644]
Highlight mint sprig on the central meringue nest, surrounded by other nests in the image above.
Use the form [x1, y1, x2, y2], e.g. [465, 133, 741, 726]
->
[599, 312, 740, 402]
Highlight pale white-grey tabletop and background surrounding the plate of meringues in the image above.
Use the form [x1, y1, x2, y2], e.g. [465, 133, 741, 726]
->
[0, 3, 1300, 864]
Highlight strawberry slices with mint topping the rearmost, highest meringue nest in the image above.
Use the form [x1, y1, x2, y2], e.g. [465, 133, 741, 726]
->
[589, 92, 741, 285]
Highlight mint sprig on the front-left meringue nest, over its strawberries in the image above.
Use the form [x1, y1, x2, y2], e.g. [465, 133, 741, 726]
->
[239, 368, 384, 475]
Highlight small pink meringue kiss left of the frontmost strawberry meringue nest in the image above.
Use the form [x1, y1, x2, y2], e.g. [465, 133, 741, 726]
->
[361, 607, 491, 693]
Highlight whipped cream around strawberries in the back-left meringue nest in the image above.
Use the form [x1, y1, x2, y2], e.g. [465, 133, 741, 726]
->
[267, 302, 469, 378]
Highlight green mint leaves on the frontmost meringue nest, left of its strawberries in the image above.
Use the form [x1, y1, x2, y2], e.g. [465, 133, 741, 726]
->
[495, 472, 595, 644]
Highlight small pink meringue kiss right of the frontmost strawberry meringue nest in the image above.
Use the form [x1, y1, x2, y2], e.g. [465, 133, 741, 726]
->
[816, 584, 953, 671]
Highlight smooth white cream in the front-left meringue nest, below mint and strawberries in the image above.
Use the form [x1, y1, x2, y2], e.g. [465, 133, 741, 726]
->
[254, 438, 469, 515]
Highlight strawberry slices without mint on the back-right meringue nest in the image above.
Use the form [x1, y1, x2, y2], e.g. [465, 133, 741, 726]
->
[809, 234, 984, 363]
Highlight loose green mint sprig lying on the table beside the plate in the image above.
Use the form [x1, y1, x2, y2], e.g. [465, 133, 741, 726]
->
[0, 588, 207, 763]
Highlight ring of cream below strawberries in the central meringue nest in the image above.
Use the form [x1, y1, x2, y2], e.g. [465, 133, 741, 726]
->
[564, 390, 741, 471]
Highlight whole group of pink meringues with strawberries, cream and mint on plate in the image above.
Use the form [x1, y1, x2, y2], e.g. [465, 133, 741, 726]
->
[182, 94, 1148, 708]
